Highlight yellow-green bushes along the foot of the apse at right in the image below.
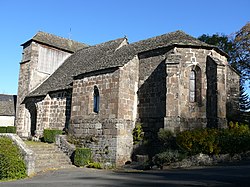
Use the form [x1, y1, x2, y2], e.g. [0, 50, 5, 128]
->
[176, 125, 250, 155]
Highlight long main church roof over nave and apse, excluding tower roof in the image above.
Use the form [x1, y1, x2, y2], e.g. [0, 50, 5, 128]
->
[29, 31, 225, 97]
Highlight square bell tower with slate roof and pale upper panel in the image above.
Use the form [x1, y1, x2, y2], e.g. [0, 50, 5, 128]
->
[16, 31, 87, 137]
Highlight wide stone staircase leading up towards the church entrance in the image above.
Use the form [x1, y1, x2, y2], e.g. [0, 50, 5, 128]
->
[25, 141, 75, 173]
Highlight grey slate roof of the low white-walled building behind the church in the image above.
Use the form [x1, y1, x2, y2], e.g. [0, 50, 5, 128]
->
[0, 94, 16, 116]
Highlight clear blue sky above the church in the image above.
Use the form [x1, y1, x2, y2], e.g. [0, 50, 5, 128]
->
[0, 0, 250, 94]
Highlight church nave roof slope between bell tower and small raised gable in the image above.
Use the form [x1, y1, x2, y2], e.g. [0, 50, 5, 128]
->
[29, 38, 131, 96]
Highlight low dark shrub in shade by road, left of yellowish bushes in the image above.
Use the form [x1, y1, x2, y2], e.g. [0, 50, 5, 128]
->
[152, 149, 182, 168]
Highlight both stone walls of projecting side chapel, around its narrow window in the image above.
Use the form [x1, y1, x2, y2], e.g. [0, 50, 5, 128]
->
[69, 58, 138, 165]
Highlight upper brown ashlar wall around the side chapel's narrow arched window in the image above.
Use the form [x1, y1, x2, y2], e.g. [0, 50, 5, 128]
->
[71, 71, 119, 121]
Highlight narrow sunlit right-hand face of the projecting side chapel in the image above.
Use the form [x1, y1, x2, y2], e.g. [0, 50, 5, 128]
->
[116, 56, 139, 165]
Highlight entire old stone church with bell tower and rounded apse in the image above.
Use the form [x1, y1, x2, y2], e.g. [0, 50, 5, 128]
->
[16, 31, 239, 165]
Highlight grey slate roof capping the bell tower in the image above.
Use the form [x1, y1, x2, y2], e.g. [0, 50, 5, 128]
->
[21, 31, 88, 53]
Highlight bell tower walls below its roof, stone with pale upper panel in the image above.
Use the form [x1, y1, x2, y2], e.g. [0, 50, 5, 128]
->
[16, 41, 70, 138]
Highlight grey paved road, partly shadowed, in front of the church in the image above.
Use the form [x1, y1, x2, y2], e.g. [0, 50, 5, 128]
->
[0, 161, 250, 187]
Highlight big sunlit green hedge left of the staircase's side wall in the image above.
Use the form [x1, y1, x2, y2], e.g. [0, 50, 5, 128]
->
[0, 137, 27, 180]
